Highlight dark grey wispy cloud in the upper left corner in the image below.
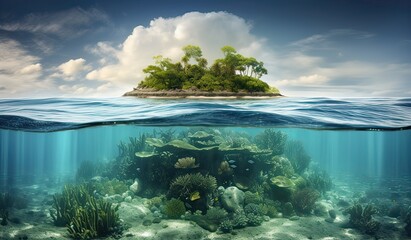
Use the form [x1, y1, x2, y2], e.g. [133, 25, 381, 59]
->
[0, 7, 108, 38]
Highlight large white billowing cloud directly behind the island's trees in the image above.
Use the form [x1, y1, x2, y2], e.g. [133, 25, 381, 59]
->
[87, 12, 267, 91]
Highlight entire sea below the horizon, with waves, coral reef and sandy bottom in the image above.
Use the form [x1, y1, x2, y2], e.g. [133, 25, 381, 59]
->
[0, 98, 411, 240]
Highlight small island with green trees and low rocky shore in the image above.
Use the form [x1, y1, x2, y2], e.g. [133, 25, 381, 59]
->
[124, 45, 282, 98]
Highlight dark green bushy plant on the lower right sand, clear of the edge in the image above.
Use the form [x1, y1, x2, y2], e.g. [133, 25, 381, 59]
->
[346, 203, 381, 235]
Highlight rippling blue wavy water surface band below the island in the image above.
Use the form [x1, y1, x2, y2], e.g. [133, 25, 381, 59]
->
[0, 97, 411, 132]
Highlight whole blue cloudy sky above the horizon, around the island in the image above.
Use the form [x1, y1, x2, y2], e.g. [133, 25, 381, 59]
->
[0, 0, 411, 98]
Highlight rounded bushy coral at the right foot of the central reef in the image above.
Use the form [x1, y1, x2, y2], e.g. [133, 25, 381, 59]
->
[292, 188, 320, 215]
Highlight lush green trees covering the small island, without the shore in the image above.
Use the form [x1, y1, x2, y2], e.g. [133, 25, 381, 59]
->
[138, 45, 271, 92]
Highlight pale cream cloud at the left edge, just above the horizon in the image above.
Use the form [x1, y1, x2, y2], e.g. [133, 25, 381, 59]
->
[0, 39, 52, 97]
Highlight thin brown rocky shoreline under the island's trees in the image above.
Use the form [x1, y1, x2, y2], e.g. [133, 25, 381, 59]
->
[123, 89, 283, 98]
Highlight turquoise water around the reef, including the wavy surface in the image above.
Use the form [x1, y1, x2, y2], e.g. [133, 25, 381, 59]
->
[0, 98, 411, 239]
